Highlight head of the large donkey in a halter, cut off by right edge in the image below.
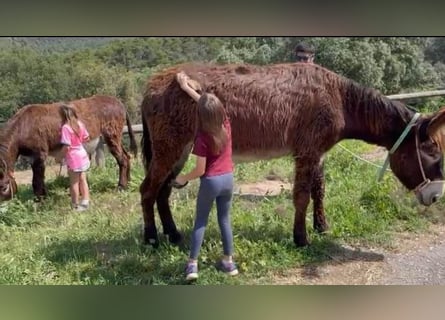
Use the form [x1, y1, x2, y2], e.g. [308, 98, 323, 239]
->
[390, 108, 445, 206]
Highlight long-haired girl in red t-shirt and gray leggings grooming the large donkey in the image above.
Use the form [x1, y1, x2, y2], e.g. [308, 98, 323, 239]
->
[174, 73, 238, 280]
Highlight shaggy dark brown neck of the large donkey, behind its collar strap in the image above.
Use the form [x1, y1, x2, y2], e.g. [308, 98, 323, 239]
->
[344, 84, 414, 149]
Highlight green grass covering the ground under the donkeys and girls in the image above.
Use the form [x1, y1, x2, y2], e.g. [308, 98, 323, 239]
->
[0, 141, 443, 285]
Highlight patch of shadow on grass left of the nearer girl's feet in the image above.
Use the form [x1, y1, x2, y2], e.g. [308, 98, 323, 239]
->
[41, 229, 182, 285]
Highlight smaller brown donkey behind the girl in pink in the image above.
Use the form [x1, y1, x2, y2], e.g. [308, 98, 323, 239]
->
[0, 96, 137, 200]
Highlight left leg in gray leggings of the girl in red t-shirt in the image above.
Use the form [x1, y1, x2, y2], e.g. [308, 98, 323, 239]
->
[189, 178, 215, 262]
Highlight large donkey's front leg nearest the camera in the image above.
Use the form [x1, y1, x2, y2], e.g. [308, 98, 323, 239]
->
[293, 158, 318, 247]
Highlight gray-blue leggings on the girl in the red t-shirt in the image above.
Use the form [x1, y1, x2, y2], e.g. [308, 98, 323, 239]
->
[190, 173, 233, 260]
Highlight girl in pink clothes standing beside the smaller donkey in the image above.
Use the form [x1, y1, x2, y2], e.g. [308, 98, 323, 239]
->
[60, 105, 90, 211]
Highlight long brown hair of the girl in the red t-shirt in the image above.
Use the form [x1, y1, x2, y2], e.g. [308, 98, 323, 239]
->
[198, 93, 227, 155]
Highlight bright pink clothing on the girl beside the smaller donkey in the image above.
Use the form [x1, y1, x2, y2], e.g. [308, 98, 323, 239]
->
[60, 121, 90, 170]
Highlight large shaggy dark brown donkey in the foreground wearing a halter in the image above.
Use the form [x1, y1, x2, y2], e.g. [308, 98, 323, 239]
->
[140, 63, 445, 246]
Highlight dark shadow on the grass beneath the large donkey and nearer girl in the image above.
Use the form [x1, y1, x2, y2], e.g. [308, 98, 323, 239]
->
[41, 218, 384, 285]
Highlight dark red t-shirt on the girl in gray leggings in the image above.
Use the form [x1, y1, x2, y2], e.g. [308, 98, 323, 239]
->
[192, 120, 233, 177]
